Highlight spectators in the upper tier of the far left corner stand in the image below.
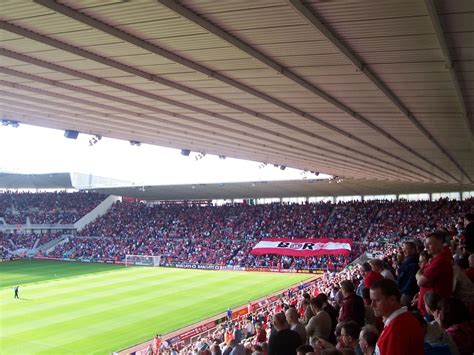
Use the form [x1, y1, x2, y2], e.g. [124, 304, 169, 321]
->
[0, 192, 105, 224]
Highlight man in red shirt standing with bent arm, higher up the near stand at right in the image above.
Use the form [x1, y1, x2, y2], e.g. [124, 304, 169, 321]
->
[416, 231, 453, 315]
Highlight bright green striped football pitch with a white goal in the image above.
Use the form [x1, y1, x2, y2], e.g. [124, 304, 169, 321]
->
[0, 260, 310, 354]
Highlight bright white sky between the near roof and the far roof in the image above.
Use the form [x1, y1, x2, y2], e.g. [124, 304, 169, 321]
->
[0, 123, 328, 185]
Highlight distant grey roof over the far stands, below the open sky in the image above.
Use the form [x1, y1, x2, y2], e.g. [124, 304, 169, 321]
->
[0, 173, 474, 201]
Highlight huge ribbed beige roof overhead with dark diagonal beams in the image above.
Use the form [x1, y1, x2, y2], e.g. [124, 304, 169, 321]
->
[0, 0, 474, 190]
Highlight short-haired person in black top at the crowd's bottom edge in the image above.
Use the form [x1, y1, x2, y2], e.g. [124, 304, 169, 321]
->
[267, 313, 302, 355]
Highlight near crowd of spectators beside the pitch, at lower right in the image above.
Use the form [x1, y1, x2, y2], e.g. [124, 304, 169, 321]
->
[174, 213, 474, 355]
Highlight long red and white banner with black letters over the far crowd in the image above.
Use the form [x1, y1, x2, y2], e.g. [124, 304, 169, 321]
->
[250, 238, 352, 256]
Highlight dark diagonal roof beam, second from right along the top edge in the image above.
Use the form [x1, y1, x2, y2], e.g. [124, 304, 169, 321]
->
[288, 0, 473, 183]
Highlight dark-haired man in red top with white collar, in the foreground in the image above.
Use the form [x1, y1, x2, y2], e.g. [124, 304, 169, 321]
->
[370, 279, 424, 355]
